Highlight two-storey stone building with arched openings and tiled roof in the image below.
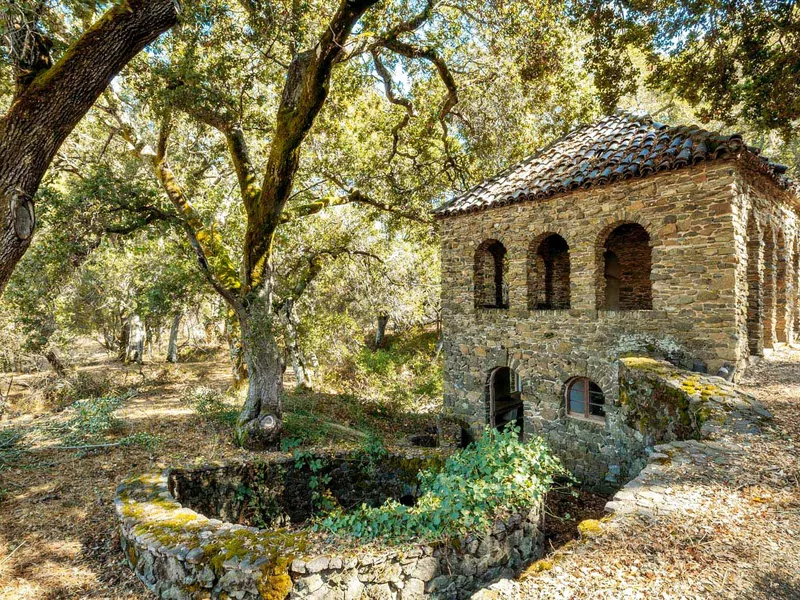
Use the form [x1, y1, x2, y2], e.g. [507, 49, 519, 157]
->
[436, 113, 800, 485]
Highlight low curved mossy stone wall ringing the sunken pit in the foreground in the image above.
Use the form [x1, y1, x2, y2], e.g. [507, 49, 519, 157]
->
[115, 456, 544, 600]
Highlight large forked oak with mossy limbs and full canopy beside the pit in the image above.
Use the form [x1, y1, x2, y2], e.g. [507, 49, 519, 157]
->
[100, 0, 584, 448]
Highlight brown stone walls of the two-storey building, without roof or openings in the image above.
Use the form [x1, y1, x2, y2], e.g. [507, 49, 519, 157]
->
[440, 160, 800, 487]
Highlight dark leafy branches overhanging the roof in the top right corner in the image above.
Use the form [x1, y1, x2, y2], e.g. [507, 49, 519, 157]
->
[572, 0, 800, 140]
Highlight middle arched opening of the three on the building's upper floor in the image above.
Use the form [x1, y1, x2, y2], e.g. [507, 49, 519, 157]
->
[528, 233, 569, 310]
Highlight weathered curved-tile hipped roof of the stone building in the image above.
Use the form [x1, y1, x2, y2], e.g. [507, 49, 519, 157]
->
[434, 111, 797, 217]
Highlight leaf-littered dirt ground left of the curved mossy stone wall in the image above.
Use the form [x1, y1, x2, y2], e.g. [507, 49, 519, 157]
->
[0, 350, 247, 599]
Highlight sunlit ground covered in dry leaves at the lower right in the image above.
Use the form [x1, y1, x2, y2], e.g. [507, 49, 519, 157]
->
[516, 349, 800, 600]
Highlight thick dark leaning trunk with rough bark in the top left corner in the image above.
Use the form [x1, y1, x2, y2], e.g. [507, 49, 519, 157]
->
[0, 0, 178, 294]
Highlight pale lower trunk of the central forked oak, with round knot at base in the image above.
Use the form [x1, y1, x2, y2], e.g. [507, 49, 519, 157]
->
[236, 296, 283, 450]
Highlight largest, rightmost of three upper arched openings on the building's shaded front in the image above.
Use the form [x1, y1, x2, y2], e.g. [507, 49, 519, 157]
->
[597, 223, 653, 310]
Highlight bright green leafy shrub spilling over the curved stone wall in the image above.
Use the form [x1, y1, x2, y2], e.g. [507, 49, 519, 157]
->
[317, 427, 565, 540]
